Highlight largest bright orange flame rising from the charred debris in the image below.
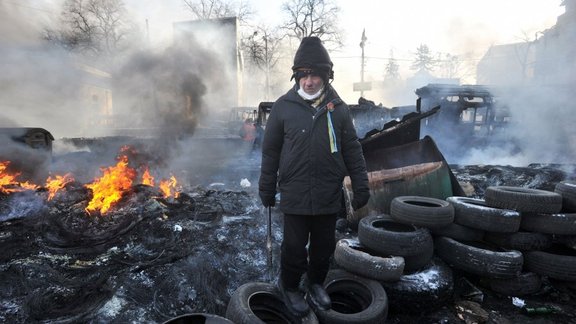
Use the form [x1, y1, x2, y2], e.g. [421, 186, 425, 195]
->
[86, 156, 136, 214]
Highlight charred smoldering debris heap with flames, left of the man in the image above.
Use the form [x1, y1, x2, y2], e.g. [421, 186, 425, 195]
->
[0, 156, 266, 322]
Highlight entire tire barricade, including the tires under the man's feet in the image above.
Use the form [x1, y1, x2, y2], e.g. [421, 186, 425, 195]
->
[226, 181, 576, 324]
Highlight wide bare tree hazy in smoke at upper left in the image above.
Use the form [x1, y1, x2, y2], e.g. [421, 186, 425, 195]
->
[45, 0, 130, 59]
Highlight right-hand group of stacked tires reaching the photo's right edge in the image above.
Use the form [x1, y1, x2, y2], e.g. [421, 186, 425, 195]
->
[433, 181, 576, 296]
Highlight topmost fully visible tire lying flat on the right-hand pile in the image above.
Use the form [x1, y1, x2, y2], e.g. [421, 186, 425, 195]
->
[484, 186, 562, 214]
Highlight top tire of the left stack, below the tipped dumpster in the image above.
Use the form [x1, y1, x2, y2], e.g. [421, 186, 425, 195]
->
[390, 196, 454, 228]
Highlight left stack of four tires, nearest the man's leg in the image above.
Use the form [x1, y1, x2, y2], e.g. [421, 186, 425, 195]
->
[334, 196, 454, 316]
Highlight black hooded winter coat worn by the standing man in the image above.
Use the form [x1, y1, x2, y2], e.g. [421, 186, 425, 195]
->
[259, 86, 370, 215]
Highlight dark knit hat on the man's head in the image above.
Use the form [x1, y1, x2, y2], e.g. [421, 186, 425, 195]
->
[292, 36, 334, 82]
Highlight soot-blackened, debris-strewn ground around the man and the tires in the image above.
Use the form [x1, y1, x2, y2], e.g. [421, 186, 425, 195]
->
[0, 138, 576, 323]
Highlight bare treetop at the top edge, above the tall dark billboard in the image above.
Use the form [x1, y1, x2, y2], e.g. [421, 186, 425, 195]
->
[184, 0, 253, 24]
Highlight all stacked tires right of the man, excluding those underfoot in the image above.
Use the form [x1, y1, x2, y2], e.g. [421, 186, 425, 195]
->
[334, 182, 576, 313]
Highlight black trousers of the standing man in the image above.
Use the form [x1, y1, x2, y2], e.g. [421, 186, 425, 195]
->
[280, 214, 336, 290]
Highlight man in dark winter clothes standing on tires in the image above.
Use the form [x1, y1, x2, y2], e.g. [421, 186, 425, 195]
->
[259, 37, 370, 316]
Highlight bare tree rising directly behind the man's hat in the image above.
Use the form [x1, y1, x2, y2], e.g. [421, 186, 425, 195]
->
[282, 0, 344, 48]
